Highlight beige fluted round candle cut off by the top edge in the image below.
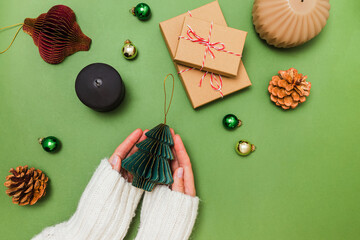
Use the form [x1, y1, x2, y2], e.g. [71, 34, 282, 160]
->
[252, 0, 330, 48]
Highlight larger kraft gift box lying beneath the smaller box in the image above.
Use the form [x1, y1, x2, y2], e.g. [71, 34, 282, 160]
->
[160, 1, 251, 108]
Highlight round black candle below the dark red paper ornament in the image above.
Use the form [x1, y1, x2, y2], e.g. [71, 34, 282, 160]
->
[75, 63, 125, 112]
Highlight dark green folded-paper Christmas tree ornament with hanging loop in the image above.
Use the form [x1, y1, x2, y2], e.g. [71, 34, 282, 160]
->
[122, 74, 174, 192]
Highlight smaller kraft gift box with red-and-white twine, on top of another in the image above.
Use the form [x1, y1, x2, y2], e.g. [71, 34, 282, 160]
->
[174, 16, 247, 77]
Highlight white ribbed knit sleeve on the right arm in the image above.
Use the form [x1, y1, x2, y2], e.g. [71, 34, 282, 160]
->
[136, 186, 199, 240]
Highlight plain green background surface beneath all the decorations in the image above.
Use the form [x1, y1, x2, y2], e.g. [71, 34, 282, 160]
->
[0, 0, 360, 240]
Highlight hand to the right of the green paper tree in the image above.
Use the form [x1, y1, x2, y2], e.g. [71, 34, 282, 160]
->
[170, 129, 196, 197]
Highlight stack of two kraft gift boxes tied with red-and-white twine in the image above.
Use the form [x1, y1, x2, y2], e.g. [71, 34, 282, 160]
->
[160, 1, 251, 108]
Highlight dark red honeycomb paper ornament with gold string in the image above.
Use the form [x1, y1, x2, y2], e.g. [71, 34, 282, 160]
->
[1, 5, 91, 64]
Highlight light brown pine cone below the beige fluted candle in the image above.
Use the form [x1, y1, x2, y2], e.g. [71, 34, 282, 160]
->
[268, 68, 311, 109]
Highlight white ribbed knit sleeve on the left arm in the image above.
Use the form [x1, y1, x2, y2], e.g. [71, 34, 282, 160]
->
[33, 159, 143, 240]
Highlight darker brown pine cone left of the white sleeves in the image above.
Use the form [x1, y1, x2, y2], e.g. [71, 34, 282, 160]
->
[4, 166, 48, 206]
